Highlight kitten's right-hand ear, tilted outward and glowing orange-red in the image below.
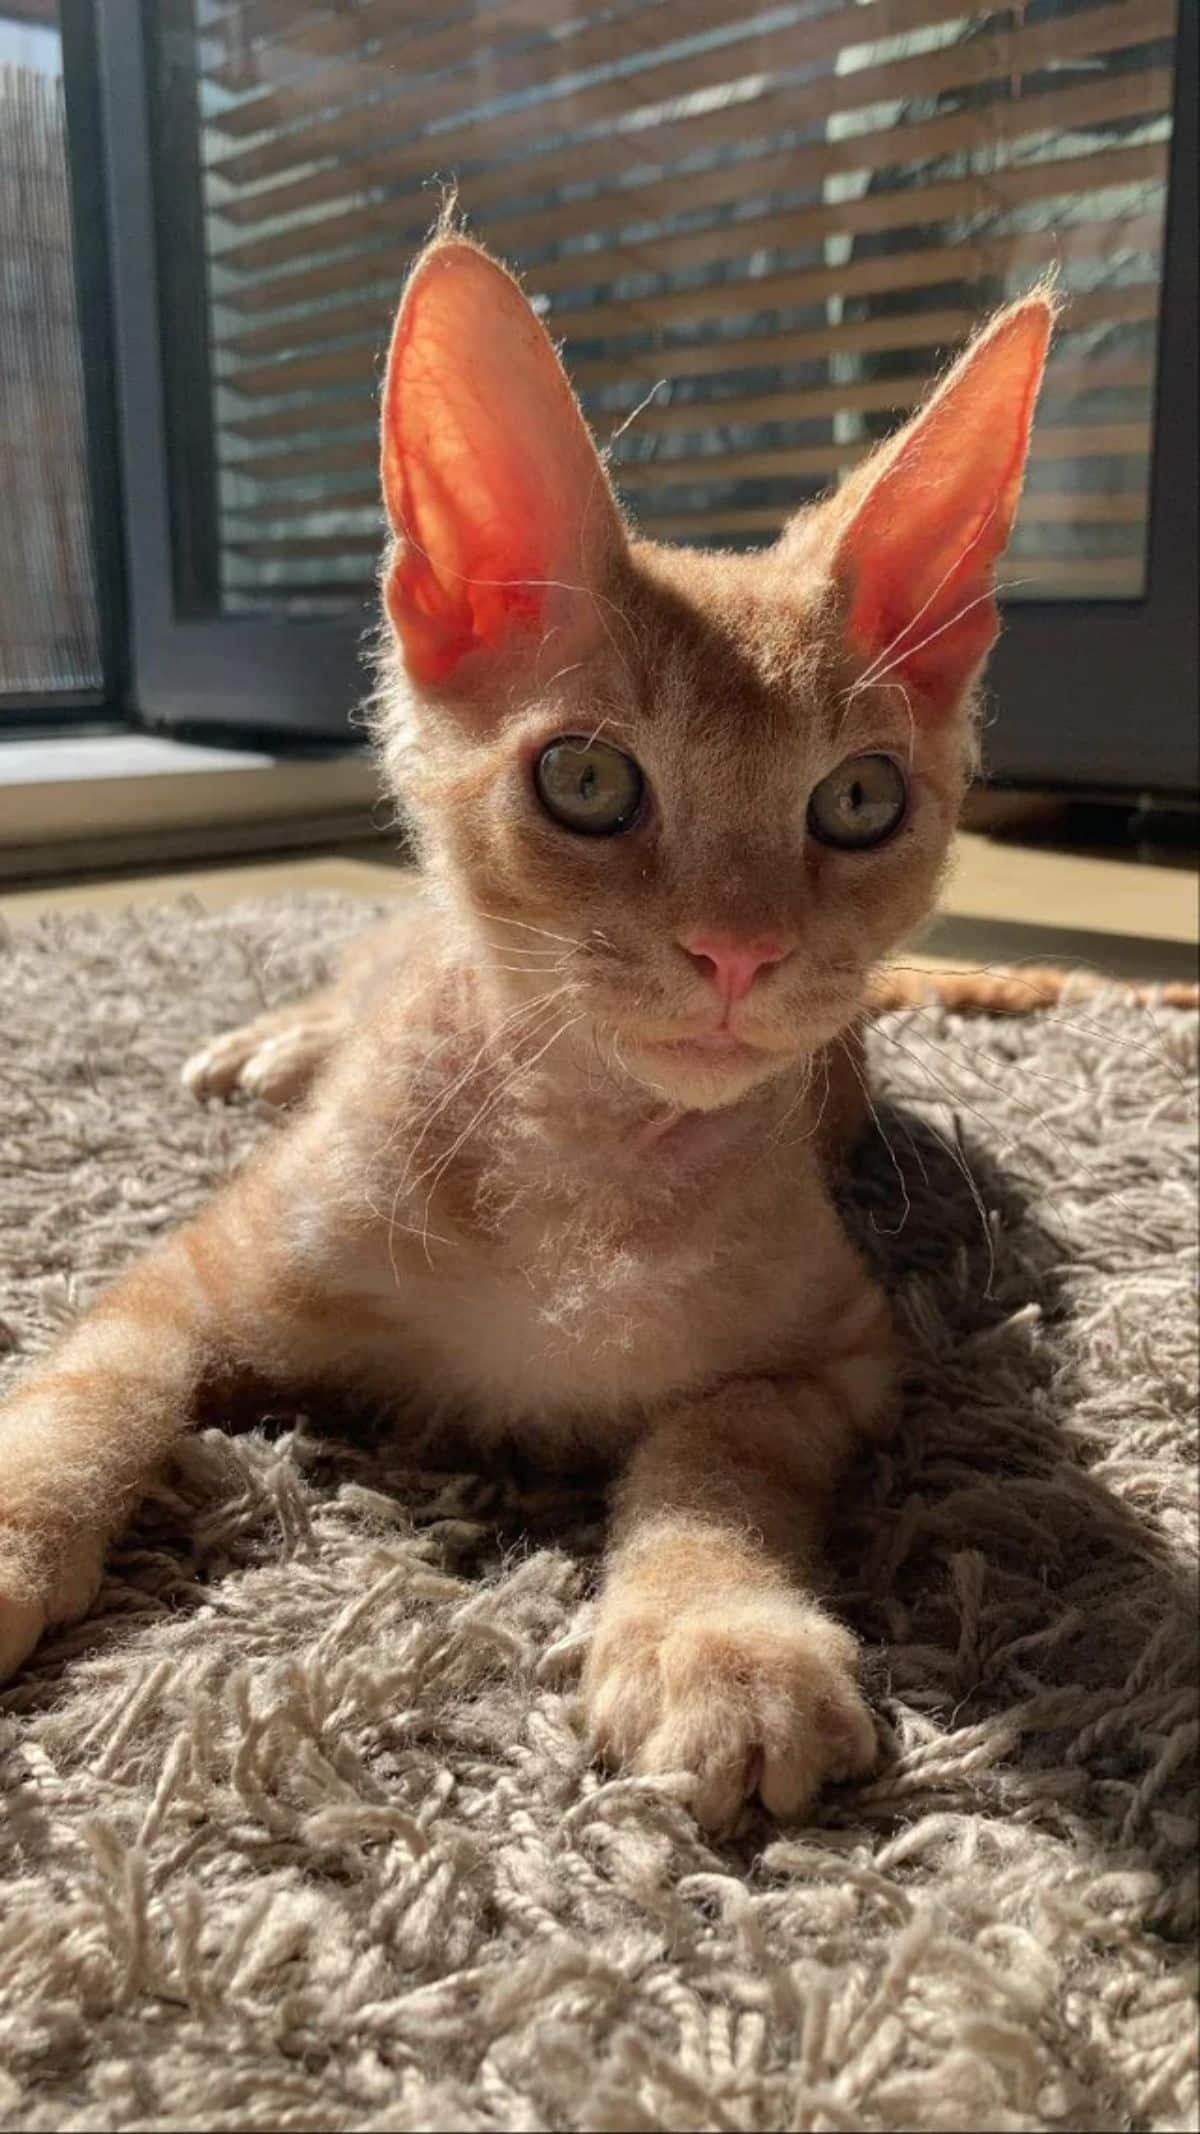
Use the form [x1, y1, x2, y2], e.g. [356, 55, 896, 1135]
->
[819, 290, 1055, 717]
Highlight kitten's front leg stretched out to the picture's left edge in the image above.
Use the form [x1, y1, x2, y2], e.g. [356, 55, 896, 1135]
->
[0, 1144, 326, 1679]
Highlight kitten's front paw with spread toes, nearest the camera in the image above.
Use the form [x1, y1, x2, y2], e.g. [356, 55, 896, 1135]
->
[583, 1592, 875, 1833]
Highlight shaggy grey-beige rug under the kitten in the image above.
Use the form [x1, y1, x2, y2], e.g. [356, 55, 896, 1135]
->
[0, 898, 1198, 2130]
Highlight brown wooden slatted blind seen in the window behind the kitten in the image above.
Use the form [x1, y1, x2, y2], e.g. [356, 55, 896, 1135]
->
[192, 0, 1177, 608]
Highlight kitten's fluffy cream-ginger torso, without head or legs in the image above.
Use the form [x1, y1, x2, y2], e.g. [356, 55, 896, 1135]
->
[204, 922, 875, 1449]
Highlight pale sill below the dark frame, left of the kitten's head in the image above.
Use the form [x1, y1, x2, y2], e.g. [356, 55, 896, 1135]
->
[0, 734, 380, 881]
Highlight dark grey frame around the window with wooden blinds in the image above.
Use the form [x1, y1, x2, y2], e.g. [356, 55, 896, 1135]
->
[64, 0, 1200, 798]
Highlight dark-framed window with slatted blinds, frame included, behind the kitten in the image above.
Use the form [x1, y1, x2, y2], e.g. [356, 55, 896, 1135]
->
[11, 0, 1196, 790]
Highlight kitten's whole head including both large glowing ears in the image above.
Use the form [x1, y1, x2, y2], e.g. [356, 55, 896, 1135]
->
[378, 237, 1053, 1105]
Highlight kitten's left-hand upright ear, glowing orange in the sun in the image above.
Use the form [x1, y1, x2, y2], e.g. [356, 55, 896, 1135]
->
[382, 237, 623, 696]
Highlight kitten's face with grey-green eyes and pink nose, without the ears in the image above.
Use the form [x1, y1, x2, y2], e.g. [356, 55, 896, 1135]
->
[390, 544, 963, 1105]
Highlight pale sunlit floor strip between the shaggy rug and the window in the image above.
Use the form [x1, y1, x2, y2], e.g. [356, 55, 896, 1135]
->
[0, 832, 1198, 980]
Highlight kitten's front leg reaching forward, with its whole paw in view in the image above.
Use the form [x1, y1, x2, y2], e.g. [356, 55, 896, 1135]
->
[583, 1289, 893, 1831]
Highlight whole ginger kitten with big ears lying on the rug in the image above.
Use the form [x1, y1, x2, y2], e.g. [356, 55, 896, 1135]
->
[0, 235, 1053, 1831]
